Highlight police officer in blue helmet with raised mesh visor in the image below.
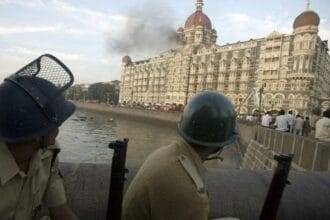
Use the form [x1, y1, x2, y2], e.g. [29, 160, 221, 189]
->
[0, 55, 76, 220]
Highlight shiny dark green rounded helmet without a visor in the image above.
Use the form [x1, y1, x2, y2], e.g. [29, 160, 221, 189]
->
[178, 91, 237, 148]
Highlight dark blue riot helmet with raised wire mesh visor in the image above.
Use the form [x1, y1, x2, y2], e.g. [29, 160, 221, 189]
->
[0, 54, 75, 143]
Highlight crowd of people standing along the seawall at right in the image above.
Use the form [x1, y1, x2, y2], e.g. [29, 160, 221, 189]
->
[261, 108, 330, 142]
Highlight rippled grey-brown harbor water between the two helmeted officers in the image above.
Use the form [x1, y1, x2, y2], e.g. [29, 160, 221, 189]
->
[58, 110, 177, 167]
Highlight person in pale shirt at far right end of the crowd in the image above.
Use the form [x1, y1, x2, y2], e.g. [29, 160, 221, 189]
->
[315, 108, 330, 142]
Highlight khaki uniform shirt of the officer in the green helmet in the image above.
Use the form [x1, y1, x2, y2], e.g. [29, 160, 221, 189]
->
[123, 141, 209, 220]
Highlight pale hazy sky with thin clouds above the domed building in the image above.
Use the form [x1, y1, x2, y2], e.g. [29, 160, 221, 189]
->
[0, 0, 330, 83]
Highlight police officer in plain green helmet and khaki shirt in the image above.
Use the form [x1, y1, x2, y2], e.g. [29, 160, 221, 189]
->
[122, 91, 236, 220]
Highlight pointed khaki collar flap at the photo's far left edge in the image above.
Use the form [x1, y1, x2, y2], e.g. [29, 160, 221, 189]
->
[0, 142, 20, 185]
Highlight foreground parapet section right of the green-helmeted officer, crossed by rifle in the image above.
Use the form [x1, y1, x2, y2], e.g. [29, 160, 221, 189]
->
[207, 169, 330, 220]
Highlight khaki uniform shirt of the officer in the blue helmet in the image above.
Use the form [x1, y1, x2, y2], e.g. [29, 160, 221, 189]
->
[0, 142, 66, 220]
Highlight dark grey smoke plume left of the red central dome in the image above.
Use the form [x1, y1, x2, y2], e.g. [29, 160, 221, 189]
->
[107, 0, 177, 58]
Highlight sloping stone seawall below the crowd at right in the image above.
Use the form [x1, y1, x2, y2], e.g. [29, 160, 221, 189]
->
[241, 126, 330, 171]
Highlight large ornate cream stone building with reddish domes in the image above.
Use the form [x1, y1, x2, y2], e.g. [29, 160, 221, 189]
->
[120, 0, 330, 114]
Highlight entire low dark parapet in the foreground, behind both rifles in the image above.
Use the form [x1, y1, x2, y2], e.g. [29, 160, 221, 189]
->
[60, 163, 330, 220]
